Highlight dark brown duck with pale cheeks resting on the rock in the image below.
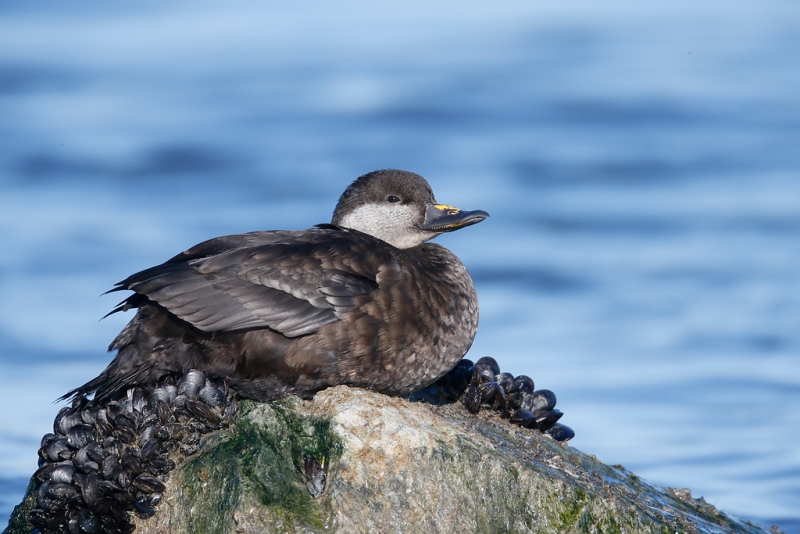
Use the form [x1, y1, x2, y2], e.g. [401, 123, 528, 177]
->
[62, 169, 489, 402]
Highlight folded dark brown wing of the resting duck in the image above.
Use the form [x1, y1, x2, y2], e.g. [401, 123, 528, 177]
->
[108, 227, 393, 337]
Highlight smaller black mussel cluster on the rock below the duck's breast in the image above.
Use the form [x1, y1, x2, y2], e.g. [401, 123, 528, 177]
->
[409, 356, 575, 441]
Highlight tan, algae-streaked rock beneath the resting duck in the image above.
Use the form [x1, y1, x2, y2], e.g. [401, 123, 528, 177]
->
[6, 386, 768, 534]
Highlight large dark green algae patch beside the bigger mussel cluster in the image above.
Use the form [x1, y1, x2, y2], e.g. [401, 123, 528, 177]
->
[170, 400, 342, 533]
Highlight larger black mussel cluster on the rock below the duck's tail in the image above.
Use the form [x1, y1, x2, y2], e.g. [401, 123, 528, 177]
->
[29, 370, 238, 534]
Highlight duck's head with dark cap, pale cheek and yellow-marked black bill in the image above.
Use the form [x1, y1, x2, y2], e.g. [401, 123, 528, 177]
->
[331, 169, 489, 248]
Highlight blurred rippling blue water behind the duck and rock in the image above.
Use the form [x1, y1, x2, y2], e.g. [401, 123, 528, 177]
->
[0, 0, 800, 533]
